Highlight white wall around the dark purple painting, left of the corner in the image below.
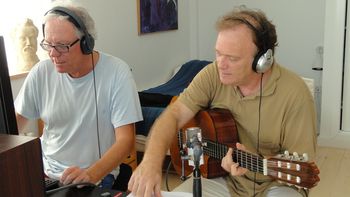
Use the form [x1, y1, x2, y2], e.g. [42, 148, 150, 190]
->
[78, 0, 191, 90]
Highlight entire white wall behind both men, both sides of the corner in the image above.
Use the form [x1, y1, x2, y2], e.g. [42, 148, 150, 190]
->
[7, 0, 325, 93]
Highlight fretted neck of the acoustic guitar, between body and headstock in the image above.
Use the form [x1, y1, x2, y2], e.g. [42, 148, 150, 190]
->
[203, 140, 267, 175]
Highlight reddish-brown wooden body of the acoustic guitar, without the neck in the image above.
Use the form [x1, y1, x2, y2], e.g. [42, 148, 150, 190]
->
[170, 109, 238, 178]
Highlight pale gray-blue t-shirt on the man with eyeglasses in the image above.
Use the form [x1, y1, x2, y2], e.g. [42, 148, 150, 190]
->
[15, 52, 142, 178]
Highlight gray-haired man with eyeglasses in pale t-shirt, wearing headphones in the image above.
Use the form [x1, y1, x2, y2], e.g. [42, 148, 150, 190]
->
[15, 2, 142, 191]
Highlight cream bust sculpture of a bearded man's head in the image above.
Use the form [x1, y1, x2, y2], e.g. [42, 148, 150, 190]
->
[12, 18, 39, 72]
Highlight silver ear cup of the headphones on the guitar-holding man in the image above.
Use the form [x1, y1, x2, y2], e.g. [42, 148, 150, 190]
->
[252, 49, 273, 73]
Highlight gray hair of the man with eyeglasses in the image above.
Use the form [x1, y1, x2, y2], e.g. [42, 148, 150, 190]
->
[43, 0, 97, 39]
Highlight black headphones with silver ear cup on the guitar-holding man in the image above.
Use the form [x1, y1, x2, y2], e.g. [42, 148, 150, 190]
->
[234, 16, 273, 73]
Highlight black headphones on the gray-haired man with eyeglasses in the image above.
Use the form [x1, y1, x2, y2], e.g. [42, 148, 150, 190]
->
[43, 6, 95, 54]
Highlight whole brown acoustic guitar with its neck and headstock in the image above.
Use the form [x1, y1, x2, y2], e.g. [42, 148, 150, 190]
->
[170, 109, 320, 189]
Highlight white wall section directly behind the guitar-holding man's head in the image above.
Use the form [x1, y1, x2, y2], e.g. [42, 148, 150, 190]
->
[191, 0, 325, 83]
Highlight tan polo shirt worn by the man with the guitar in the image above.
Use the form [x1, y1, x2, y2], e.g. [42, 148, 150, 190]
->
[179, 62, 317, 196]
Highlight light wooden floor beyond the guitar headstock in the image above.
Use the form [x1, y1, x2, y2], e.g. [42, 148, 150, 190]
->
[162, 147, 350, 197]
